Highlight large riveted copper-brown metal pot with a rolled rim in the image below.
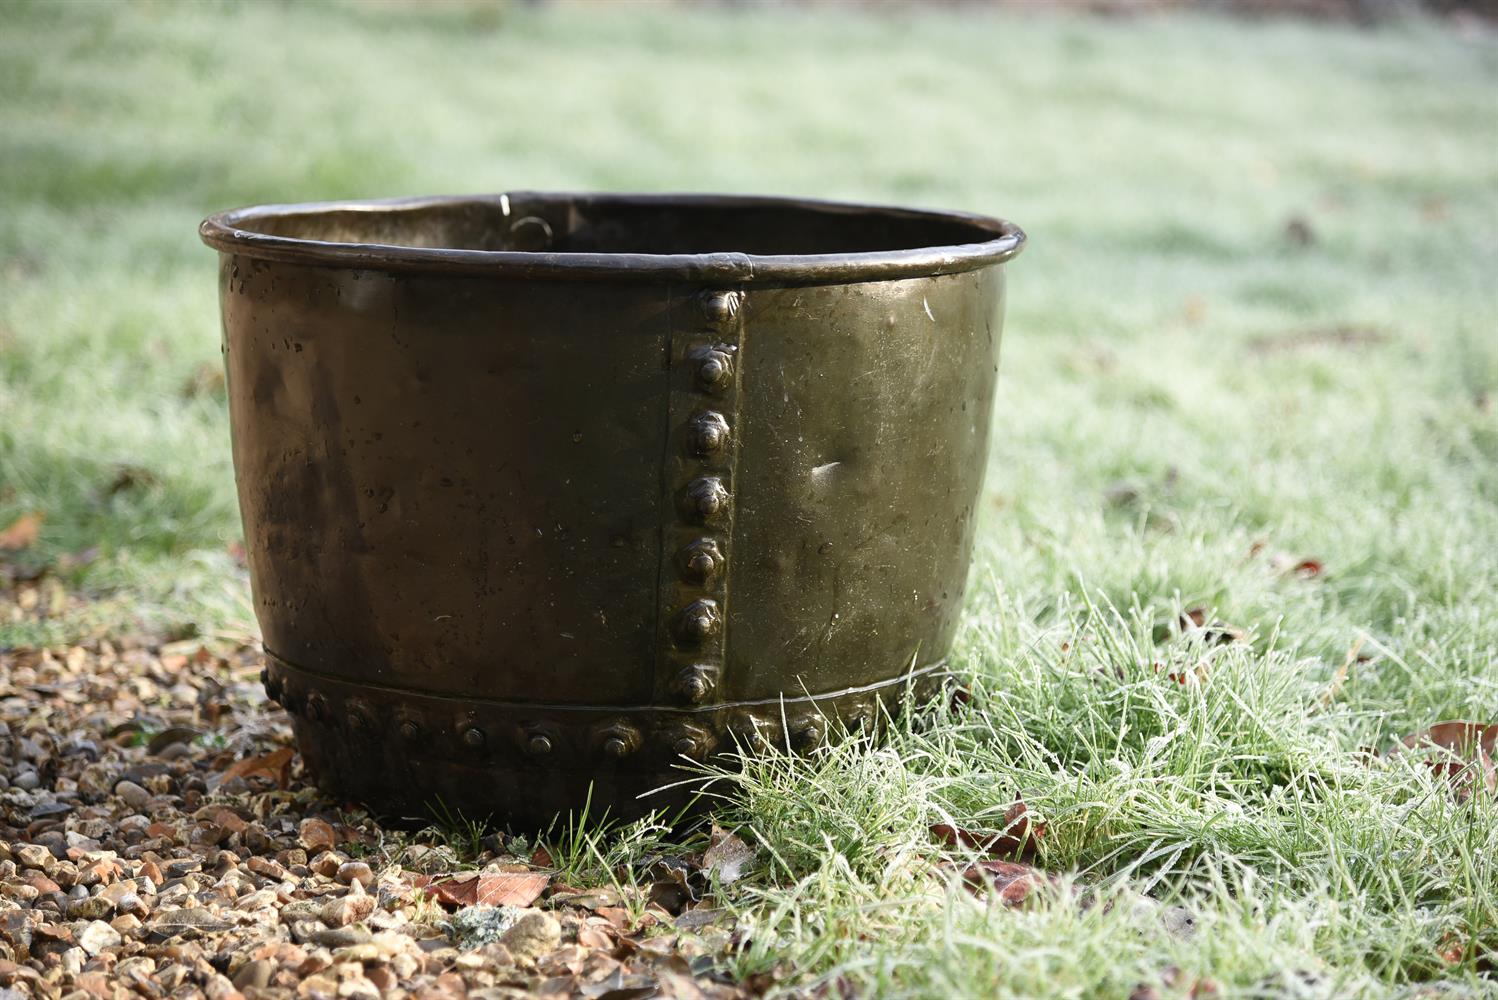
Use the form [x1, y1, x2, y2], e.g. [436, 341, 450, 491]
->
[201, 193, 1025, 825]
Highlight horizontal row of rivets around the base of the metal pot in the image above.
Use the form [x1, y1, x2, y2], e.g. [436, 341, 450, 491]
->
[261, 671, 876, 759]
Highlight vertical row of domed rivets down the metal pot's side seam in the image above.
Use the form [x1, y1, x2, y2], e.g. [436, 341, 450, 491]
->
[656, 289, 743, 705]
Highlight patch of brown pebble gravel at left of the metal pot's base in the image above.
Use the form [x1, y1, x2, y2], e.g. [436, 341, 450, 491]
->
[0, 637, 731, 1000]
